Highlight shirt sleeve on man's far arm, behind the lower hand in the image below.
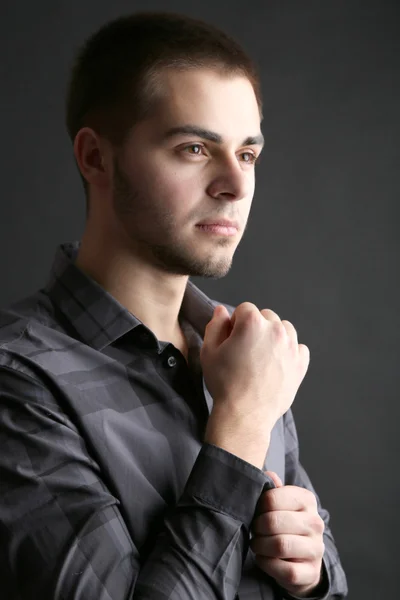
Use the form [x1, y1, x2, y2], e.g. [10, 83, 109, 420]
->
[276, 409, 348, 600]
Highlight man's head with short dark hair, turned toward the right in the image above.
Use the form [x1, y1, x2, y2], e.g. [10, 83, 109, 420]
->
[66, 13, 262, 277]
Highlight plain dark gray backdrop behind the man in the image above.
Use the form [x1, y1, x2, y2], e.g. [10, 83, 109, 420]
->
[0, 0, 400, 600]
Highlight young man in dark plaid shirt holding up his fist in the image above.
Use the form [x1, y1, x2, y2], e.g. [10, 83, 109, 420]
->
[0, 13, 347, 600]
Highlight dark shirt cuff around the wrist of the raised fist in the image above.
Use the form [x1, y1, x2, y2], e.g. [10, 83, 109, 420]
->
[184, 442, 275, 530]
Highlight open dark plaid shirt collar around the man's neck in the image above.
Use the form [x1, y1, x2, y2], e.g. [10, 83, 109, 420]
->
[44, 241, 219, 350]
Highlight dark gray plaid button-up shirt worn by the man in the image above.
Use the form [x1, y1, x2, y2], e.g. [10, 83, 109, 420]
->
[0, 242, 347, 600]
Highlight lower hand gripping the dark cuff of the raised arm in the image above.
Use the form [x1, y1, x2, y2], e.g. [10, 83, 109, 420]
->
[250, 471, 325, 598]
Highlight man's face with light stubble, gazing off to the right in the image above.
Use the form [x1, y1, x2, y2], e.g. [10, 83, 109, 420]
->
[113, 70, 261, 278]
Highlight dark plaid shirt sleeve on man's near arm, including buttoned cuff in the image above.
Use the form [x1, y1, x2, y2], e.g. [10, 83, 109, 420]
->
[0, 367, 274, 600]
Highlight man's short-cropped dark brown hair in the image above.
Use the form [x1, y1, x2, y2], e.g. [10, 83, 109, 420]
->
[66, 11, 262, 216]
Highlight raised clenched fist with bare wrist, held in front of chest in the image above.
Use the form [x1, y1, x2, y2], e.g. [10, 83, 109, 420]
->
[200, 302, 310, 469]
